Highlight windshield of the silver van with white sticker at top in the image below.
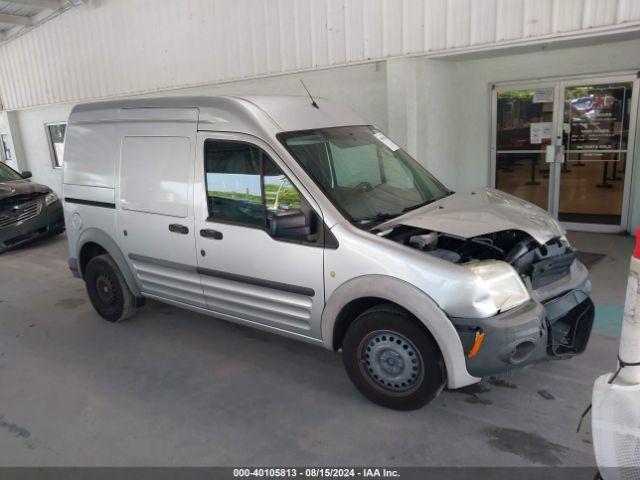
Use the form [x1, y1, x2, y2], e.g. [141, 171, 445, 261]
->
[278, 126, 450, 225]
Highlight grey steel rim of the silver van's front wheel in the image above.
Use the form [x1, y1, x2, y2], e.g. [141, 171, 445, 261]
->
[358, 330, 425, 394]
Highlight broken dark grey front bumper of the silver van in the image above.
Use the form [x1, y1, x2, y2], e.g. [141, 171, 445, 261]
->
[451, 261, 595, 378]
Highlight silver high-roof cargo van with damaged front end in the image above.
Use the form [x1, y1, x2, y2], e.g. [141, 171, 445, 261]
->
[64, 96, 594, 410]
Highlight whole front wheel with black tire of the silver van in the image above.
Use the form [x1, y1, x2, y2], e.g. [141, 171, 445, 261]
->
[342, 304, 446, 410]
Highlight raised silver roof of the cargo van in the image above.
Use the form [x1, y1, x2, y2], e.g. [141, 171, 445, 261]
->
[69, 95, 370, 132]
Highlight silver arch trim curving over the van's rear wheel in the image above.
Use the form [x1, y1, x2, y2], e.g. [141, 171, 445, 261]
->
[76, 228, 141, 297]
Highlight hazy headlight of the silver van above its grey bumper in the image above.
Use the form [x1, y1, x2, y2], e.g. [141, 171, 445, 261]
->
[464, 260, 531, 313]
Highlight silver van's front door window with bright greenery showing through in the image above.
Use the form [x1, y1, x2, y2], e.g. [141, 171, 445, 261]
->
[204, 140, 320, 243]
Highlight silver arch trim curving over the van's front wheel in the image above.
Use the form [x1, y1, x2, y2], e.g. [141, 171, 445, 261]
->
[321, 275, 480, 388]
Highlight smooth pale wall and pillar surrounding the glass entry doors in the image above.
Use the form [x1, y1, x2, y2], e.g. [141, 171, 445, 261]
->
[360, 36, 640, 230]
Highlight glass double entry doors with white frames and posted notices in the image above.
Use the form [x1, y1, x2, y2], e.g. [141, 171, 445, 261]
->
[492, 78, 638, 231]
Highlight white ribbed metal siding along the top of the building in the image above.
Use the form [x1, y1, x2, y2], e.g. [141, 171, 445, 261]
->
[0, 0, 640, 110]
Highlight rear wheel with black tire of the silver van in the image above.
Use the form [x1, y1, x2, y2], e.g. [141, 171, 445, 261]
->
[84, 254, 136, 322]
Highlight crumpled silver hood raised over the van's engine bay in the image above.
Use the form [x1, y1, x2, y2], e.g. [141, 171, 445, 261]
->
[377, 188, 565, 244]
